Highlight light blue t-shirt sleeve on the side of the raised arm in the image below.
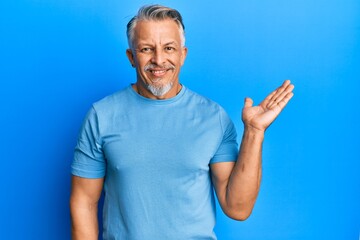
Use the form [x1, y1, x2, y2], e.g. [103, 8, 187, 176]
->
[210, 109, 239, 164]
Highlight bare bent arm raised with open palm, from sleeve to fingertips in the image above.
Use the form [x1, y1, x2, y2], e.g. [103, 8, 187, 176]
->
[211, 80, 294, 220]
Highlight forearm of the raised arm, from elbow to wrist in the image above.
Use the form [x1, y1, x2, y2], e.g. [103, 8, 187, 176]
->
[226, 128, 264, 219]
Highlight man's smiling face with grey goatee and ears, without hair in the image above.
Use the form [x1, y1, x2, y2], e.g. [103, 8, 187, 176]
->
[126, 20, 187, 98]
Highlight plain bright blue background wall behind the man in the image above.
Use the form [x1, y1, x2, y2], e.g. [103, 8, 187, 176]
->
[0, 0, 360, 240]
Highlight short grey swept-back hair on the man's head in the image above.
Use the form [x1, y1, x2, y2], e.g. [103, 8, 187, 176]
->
[126, 5, 185, 48]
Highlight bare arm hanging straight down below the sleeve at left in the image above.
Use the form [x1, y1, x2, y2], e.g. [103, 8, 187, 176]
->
[70, 176, 104, 240]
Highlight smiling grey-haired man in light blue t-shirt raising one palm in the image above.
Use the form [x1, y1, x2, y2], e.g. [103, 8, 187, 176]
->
[70, 5, 294, 240]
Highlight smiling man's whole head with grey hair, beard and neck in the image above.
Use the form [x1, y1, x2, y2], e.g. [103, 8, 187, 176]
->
[126, 5, 187, 99]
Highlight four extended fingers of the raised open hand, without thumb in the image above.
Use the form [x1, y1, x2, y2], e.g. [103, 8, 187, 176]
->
[266, 80, 294, 109]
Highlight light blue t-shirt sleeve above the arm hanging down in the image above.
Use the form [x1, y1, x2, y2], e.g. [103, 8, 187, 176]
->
[71, 107, 106, 178]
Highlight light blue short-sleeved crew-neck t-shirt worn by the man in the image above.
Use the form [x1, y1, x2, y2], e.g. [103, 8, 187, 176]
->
[72, 86, 238, 240]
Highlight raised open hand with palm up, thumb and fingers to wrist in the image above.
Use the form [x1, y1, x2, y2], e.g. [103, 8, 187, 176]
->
[242, 80, 294, 132]
